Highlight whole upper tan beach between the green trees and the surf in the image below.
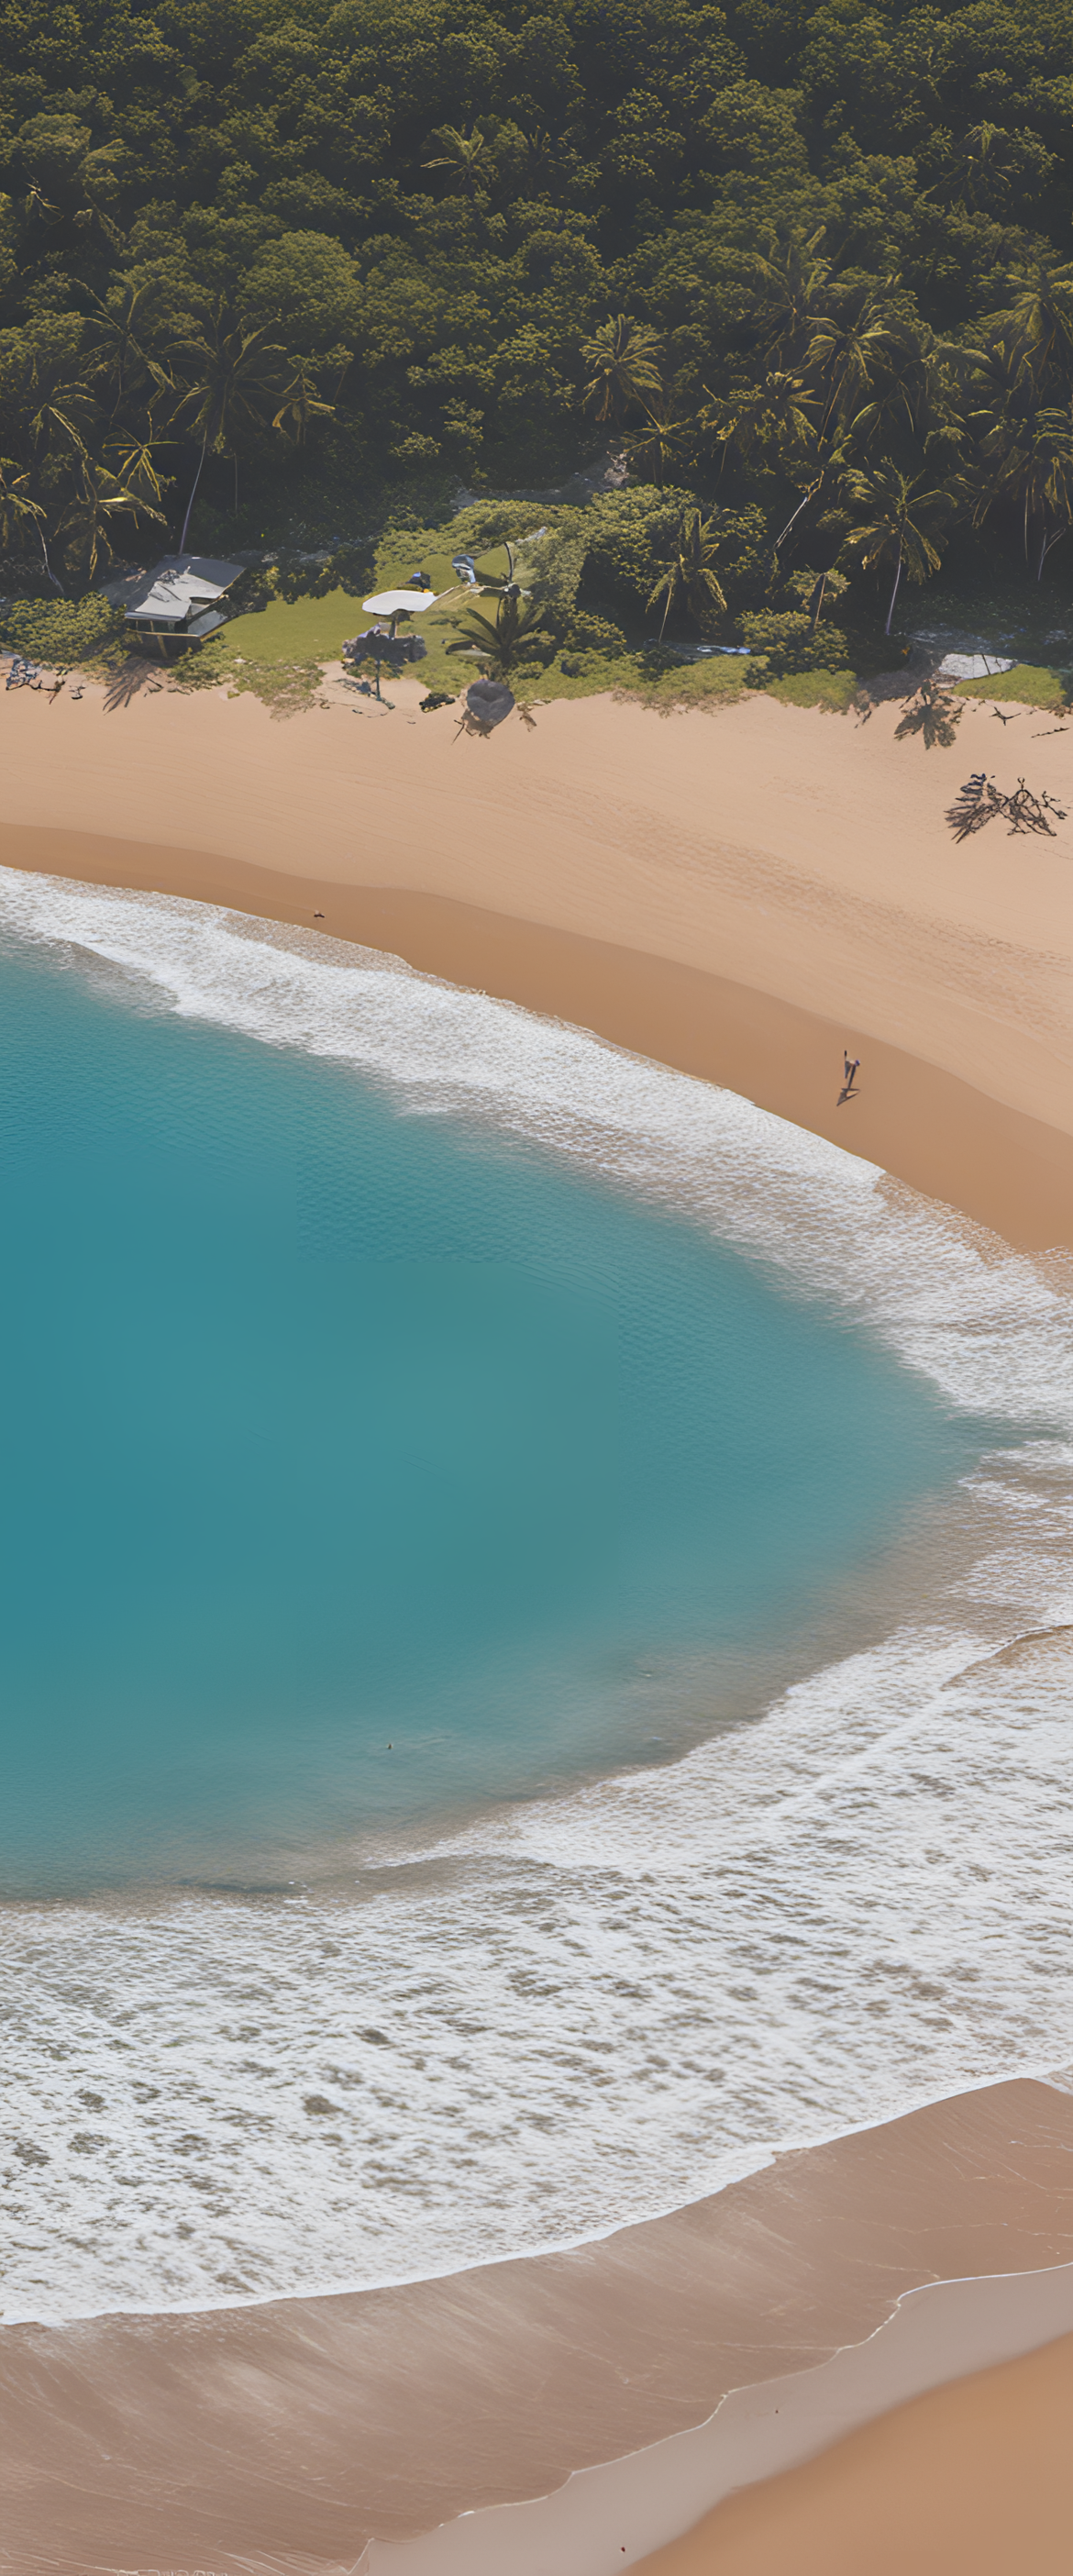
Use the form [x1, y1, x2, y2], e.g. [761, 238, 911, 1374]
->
[0, 683, 1073, 1247]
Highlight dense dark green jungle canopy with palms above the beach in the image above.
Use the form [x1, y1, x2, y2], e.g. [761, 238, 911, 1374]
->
[0, 0, 1073, 651]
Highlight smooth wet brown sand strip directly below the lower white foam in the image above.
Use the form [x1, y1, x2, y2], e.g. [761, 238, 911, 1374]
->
[0, 2082, 1073, 2576]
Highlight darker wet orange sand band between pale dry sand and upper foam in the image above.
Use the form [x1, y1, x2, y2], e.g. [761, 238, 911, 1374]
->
[0, 827, 1073, 1252]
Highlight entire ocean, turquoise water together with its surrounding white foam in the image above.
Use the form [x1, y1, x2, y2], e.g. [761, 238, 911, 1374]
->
[0, 871, 1073, 2318]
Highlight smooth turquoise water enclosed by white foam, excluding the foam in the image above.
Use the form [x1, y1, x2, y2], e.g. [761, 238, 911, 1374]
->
[0, 950, 980, 1891]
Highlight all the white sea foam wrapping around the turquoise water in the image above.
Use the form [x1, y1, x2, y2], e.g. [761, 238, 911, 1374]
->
[0, 876, 1073, 2315]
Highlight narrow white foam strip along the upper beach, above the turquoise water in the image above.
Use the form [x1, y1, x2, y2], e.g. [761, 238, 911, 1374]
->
[0, 871, 1073, 1432]
